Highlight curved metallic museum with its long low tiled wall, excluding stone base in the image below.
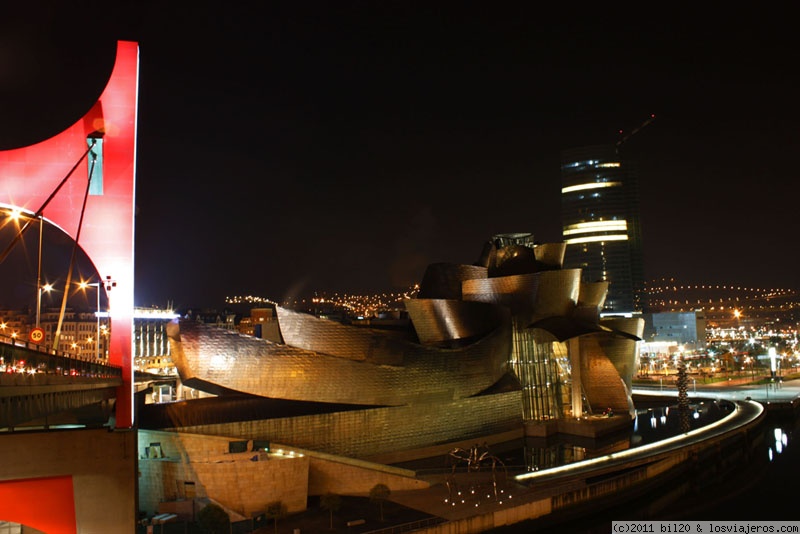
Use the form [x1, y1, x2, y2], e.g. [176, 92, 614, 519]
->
[155, 234, 643, 458]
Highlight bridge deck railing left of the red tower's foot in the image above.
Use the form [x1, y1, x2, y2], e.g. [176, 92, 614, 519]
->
[0, 334, 122, 378]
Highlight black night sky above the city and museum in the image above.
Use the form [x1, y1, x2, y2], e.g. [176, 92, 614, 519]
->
[0, 1, 800, 308]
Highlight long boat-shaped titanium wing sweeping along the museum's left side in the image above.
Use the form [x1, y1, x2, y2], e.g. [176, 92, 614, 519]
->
[167, 314, 511, 406]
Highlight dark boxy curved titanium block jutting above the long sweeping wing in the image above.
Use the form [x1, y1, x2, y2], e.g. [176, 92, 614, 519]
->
[405, 298, 510, 345]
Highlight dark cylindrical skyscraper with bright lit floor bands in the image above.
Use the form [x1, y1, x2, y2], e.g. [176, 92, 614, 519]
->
[561, 145, 644, 313]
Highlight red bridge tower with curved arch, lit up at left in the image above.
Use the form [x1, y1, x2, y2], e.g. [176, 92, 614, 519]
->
[0, 41, 139, 428]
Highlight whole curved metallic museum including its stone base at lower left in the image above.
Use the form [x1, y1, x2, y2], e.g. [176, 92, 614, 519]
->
[131, 233, 644, 515]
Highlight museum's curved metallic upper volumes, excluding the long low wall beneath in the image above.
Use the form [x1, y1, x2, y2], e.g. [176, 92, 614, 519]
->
[167, 234, 644, 450]
